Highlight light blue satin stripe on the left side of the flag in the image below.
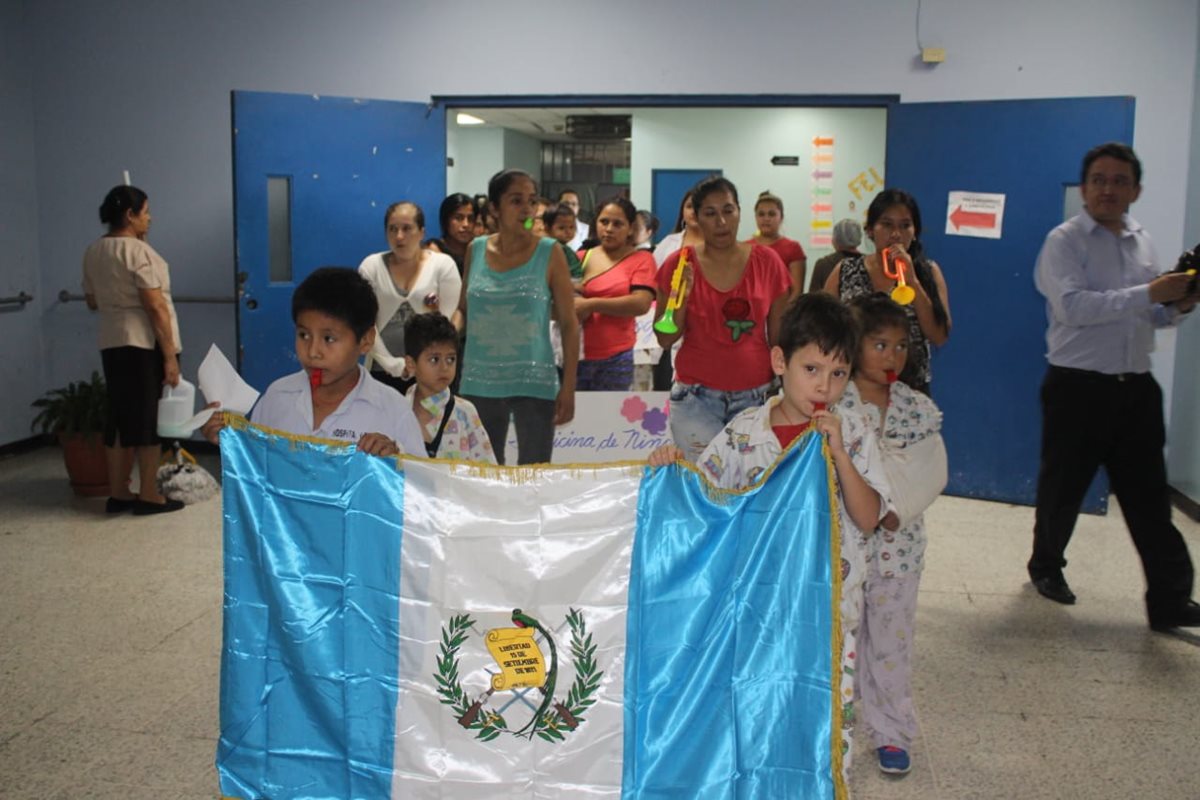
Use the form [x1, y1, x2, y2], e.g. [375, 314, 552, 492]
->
[217, 428, 404, 800]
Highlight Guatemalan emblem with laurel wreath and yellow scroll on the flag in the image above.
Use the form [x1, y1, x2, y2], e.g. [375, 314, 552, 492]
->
[433, 608, 604, 742]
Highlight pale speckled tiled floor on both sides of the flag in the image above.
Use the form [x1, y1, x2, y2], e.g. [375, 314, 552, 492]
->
[0, 450, 1200, 800]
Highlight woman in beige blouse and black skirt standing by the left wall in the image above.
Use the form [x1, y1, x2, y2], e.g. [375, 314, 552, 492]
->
[83, 186, 184, 515]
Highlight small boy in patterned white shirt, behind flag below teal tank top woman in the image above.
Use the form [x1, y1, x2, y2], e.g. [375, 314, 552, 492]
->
[404, 312, 496, 464]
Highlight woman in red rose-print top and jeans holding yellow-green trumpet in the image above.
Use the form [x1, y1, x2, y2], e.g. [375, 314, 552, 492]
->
[655, 178, 792, 459]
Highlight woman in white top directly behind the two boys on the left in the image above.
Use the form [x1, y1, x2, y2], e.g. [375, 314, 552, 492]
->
[359, 201, 462, 392]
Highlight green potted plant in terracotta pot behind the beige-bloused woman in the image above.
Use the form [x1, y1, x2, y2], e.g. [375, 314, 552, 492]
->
[30, 372, 108, 497]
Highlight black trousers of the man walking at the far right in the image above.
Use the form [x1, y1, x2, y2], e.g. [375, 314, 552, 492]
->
[1028, 367, 1193, 618]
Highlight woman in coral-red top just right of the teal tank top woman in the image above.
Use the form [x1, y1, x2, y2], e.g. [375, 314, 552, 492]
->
[575, 197, 658, 391]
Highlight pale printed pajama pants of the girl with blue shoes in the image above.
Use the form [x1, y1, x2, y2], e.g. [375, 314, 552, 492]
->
[857, 559, 920, 750]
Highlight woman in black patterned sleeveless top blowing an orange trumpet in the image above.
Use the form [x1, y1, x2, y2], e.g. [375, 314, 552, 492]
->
[824, 188, 950, 395]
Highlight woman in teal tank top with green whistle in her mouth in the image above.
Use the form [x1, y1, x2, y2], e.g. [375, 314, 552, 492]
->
[454, 169, 580, 464]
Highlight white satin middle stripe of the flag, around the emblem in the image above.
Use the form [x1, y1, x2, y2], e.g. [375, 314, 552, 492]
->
[392, 461, 642, 800]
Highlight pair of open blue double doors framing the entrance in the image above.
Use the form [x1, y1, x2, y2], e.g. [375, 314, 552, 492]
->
[233, 91, 1134, 511]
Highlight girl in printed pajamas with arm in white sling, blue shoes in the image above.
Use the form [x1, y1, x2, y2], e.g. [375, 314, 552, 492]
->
[835, 294, 947, 775]
